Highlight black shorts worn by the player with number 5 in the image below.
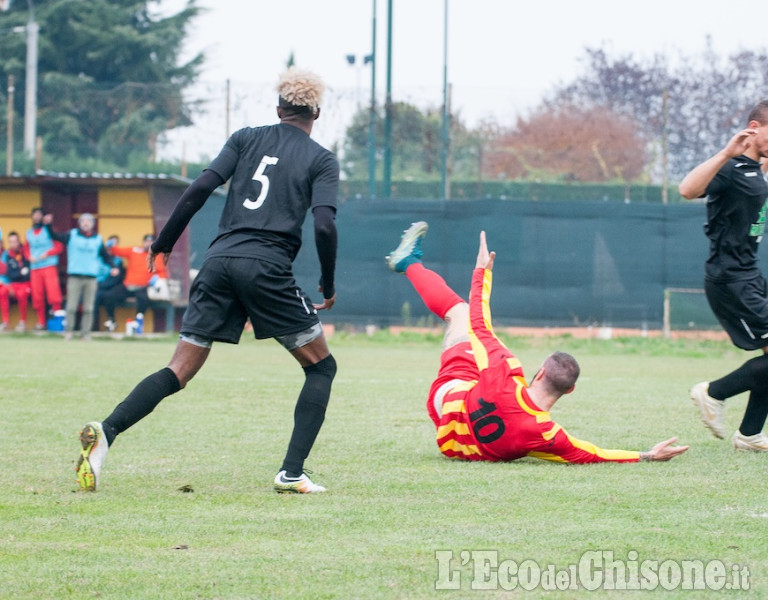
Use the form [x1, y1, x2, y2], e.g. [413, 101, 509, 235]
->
[180, 257, 320, 344]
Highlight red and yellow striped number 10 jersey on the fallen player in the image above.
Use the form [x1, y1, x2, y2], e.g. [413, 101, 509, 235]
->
[428, 268, 639, 463]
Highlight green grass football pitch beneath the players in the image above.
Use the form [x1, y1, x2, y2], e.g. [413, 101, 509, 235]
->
[0, 332, 768, 599]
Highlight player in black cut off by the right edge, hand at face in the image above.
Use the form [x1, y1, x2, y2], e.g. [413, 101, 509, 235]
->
[680, 100, 768, 452]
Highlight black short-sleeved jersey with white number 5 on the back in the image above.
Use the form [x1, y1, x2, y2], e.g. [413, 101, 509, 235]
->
[206, 123, 339, 262]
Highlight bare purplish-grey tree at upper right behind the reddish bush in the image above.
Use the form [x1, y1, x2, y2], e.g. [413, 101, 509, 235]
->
[545, 42, 768, 179]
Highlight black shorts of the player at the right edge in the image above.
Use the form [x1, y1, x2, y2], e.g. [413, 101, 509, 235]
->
[704, 275, 768, 350]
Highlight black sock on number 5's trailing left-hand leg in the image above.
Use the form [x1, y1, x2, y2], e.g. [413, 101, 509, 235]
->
[101, 367, 181, 446]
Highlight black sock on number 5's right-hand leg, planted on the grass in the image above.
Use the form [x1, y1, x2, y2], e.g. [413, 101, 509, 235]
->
[281, 355, 336, 477]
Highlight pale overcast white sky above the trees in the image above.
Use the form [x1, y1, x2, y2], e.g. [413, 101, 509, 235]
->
[161, 0, 765, 161]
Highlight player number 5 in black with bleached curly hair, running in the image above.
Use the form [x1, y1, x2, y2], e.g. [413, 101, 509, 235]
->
[76, 68, 339, 493]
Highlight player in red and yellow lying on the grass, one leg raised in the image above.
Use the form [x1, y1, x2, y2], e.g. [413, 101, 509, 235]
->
[387, 221, 688, 463]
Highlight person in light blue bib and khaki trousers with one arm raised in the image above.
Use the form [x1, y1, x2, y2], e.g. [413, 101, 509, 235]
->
[43, 213, 111, 340]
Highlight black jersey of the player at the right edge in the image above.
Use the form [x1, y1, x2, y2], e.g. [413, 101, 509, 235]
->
[704, 156, 768, 281]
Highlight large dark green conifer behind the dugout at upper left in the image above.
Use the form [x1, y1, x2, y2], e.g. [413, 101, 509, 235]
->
[0, 0, 203, 165]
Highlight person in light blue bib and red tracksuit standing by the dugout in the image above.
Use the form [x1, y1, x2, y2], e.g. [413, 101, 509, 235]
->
[24, 207, 64, 331]
